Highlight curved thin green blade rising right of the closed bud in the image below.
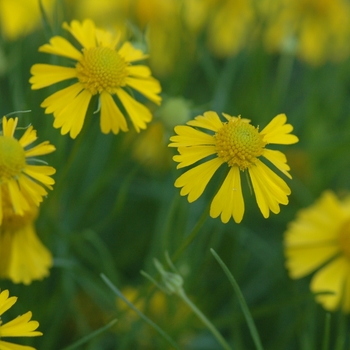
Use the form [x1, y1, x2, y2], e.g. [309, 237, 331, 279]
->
[210, 249, 263, 350]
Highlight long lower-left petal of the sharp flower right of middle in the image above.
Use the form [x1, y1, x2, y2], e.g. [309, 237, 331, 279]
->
[175, 158, 224, 203]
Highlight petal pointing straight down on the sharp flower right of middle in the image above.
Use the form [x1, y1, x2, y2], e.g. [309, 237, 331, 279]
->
[210, 167, 244, 223]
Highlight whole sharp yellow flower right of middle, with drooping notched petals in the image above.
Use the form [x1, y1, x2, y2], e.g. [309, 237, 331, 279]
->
[169, 111, 298, 223]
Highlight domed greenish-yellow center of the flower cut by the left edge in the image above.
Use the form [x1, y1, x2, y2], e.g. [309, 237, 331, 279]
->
[0, 136, 26, 184]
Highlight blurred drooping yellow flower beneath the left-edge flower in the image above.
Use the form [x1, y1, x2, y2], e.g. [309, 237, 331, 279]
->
[0, 190, 52, 284]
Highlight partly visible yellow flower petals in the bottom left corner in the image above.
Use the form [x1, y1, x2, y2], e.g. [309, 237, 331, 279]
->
[0, 290, 43, 350]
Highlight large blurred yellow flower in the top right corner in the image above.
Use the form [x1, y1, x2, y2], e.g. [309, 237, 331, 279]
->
[258, 0, 350, 65]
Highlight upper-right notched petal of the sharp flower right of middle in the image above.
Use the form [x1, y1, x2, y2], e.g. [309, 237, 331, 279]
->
[260, 114, 299, 145]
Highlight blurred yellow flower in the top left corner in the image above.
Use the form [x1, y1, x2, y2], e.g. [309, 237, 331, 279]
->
[0, 0, 54, 40]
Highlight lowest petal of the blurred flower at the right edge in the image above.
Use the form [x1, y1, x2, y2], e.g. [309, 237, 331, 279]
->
[310, 256, 350, 311]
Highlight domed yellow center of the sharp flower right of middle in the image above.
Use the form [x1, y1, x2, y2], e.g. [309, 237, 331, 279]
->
[215, 118, 266, 170]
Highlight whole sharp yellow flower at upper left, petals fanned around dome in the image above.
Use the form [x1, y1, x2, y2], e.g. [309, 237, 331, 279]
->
[30, 20, 161, 138]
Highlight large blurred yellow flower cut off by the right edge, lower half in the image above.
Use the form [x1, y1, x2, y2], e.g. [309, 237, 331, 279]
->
[284, 191, 350, 312]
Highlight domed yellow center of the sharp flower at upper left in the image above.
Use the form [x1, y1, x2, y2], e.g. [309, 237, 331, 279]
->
[76, 47, 128, 95]
